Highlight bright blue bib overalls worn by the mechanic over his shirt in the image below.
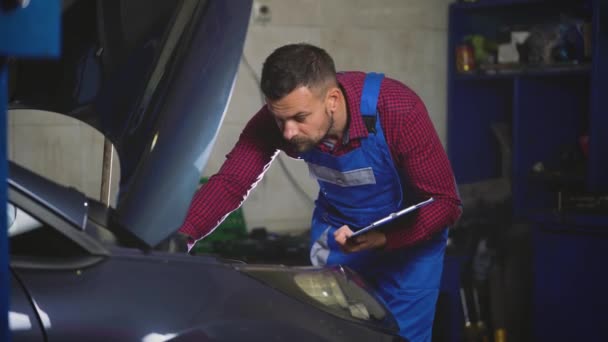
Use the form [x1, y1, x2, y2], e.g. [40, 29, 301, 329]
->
[301, 73, 447, 341]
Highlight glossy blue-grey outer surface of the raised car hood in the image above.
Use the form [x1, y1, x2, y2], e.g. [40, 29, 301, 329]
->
[118, 1, 249, 245]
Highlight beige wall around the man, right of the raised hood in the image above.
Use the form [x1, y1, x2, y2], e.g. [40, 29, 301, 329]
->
[204, 0, 452, 231]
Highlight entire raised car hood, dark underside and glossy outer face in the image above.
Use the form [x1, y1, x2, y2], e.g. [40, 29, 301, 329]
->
[9, 0, 251, 246]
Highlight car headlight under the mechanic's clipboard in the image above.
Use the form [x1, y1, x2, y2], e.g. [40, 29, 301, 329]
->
[235, 265, 397, 330]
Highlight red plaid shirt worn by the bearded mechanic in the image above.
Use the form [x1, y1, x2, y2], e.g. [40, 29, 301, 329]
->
[180, 72, 461, 249]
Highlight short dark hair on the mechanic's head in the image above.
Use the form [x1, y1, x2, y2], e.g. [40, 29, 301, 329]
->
[260, 43, 337, 100]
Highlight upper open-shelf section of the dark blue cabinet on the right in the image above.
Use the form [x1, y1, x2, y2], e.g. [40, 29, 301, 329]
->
[448, 0, 608, 199]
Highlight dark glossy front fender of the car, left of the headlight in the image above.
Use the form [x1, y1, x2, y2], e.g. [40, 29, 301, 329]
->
[14, 249, 395, 341]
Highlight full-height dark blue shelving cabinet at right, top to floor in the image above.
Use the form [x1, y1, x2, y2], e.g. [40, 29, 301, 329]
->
[447, 0, 608, 341]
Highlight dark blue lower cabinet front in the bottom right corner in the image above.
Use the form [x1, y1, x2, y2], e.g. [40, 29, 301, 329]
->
[532, 222, 608, 342]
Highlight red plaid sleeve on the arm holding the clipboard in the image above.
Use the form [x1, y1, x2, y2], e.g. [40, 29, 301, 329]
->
[386, 95, 461, 249]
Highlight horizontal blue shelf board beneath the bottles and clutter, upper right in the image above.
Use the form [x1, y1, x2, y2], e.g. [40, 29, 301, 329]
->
[454, 64, 591, 80]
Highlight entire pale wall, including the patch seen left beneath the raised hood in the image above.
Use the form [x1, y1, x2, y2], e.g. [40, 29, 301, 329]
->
[9, 0, 452, 232]
